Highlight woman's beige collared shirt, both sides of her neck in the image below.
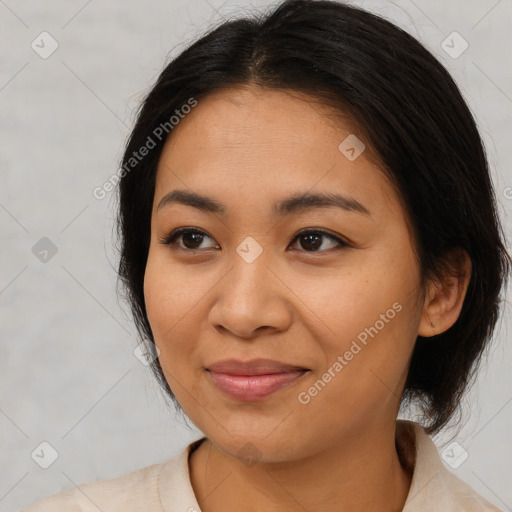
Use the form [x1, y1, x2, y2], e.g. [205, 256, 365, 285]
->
[21, 420, 503, 512]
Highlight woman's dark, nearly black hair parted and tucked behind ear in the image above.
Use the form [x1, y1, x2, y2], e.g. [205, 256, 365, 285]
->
[117, 0, 512, 434]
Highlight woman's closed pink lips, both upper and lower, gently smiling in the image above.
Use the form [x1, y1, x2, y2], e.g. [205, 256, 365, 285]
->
[206, 359, 309, 401]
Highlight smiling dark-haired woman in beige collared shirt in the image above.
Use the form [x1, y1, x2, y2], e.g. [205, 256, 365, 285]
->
[26, 0, 510, 512]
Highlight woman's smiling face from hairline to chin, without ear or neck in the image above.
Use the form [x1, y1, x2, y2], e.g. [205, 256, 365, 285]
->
[144, 88, 423, 462]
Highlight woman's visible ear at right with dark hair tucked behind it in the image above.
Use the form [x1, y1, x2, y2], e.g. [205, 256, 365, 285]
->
[418, 249, 472, 337]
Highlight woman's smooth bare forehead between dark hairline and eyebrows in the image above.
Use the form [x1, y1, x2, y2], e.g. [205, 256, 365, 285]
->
[155, 87, 397, 219]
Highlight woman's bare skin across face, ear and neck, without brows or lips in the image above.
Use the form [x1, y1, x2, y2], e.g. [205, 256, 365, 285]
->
[144, 87, 470, 512]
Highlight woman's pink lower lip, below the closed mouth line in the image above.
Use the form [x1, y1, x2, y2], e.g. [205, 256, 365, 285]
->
[208, 370, 307, 400]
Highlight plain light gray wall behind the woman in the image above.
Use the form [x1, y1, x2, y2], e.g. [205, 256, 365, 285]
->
[0, 0, 512, 512]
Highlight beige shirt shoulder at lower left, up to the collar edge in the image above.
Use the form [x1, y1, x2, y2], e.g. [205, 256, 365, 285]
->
[21, 459, 165, 512]
